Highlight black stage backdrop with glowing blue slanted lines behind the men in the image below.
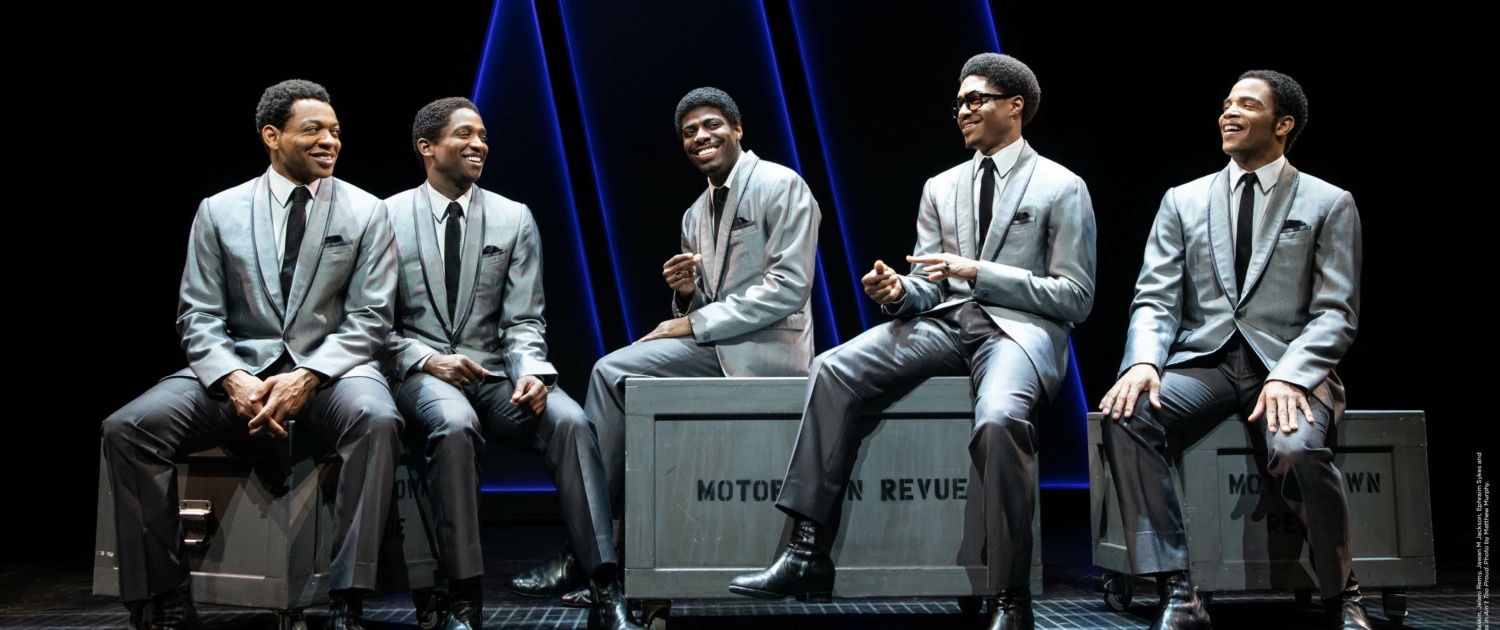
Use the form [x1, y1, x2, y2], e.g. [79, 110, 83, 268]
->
[23, 0, 1470, 582]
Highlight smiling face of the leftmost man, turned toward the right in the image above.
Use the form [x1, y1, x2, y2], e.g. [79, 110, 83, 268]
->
[261, 99, 342, 185]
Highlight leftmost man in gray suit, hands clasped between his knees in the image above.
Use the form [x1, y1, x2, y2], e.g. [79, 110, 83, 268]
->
[102, 80, 402, 629]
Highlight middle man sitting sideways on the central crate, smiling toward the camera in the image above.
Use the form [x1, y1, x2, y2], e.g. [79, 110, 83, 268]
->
[512, 87, 821, 606]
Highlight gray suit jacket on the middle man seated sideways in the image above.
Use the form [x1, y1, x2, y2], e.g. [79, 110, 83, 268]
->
[672, 152, 821, 377]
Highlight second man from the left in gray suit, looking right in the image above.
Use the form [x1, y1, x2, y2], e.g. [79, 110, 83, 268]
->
[384, 98, 639, 630]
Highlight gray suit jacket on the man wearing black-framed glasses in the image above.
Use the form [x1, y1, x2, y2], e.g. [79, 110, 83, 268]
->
[888, 144, 1095, 396]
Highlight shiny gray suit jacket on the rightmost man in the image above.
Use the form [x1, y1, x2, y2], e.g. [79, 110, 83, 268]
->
[1121, 162, 1361, 411]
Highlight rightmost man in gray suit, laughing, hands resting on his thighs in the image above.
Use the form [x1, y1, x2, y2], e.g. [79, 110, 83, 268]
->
[1100, 71, 1370, 629]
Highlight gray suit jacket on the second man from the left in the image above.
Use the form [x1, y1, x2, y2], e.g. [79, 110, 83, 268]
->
[383, 186, 557, 384]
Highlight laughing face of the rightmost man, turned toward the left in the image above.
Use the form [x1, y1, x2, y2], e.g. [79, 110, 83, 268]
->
[1220, 78, 1296, 171]
